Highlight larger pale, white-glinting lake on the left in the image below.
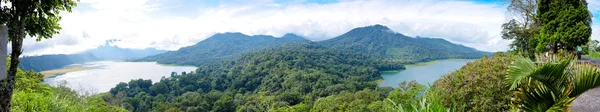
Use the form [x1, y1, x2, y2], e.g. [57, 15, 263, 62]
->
[44, 61, 196, 92]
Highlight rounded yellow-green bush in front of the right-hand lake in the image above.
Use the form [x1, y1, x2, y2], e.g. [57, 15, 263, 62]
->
[429, 53, 512, 112]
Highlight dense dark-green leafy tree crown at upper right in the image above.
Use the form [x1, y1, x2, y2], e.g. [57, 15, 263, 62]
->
[536, 0, 592, 52]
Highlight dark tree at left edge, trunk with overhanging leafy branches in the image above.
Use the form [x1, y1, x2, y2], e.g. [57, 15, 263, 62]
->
[0, 0, 77, 112]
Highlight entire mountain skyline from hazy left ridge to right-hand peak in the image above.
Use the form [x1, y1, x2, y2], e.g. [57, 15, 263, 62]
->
[20, 25, 487, 71]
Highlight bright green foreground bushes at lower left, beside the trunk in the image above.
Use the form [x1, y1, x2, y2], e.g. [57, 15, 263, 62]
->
[11, 69, 126, 112]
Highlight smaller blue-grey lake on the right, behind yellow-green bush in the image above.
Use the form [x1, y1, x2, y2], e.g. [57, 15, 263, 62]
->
[379, 59, 474, 88]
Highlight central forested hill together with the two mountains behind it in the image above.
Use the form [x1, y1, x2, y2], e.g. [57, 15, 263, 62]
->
[103, 25, 486, 112]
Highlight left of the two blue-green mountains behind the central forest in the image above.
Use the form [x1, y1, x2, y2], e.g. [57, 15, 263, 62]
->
[132, 33, 309, 66]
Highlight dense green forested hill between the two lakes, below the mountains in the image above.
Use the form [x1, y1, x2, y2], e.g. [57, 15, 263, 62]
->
[104, 43, 402, 112]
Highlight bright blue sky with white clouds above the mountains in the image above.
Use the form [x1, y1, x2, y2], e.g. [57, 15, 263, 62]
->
[16, 0, 600, 56]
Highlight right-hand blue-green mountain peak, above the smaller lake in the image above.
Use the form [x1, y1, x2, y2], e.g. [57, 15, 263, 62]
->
[319, 25, 486, 63]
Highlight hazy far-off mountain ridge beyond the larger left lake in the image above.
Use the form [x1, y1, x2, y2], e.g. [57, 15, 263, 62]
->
[19, 40, 167, 72]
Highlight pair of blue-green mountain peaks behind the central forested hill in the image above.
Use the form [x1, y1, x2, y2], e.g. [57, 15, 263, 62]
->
[133, 25, 486, 66]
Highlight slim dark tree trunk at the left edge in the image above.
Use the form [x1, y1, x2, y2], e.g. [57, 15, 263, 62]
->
[0, 20, 25, 112]
